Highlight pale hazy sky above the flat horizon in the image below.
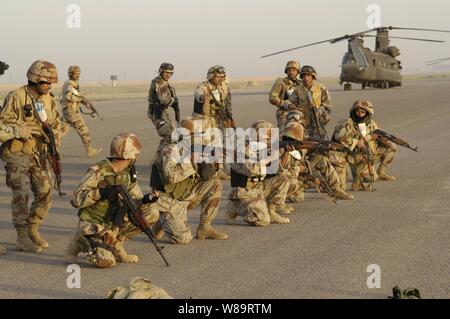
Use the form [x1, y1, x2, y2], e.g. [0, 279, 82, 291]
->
[0, 0, 450, 83]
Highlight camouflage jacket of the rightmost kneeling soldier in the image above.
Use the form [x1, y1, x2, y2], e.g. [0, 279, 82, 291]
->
[333, 118, 380, 152]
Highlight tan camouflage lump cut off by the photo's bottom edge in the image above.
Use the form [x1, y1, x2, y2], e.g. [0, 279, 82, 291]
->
[106, 277, 173, 299]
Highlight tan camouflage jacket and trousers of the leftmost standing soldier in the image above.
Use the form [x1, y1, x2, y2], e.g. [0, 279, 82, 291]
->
[0, 86, 61, 235]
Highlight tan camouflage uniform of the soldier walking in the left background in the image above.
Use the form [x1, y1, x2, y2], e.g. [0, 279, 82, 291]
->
[61, 79, 92, 150]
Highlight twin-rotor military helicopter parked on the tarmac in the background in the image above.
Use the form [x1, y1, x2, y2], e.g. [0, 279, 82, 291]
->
[261, 26, 450, 91]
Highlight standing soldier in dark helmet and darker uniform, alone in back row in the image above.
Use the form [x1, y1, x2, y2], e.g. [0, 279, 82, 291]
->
[148, 63, 180, 140]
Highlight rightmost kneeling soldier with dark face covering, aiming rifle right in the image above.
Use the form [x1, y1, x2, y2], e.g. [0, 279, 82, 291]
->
[333, 101, 397, 191]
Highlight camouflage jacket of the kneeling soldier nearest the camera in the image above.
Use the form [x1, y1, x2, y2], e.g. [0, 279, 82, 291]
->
[71, 159, 143, 224]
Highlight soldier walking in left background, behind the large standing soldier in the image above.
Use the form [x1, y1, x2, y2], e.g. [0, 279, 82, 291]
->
[61, 65, 102, 157]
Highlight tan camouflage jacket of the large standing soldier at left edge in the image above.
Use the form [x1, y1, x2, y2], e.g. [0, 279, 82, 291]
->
[0, 86, 61, 164]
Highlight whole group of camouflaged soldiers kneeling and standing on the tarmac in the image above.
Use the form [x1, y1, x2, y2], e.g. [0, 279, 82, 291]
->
[0, 60, 396, 268]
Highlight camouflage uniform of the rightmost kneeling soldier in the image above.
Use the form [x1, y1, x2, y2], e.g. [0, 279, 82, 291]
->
[333, 102, 397, 189]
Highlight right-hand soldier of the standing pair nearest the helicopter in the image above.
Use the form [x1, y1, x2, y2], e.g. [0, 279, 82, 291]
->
[289, 65, 331, 139]
